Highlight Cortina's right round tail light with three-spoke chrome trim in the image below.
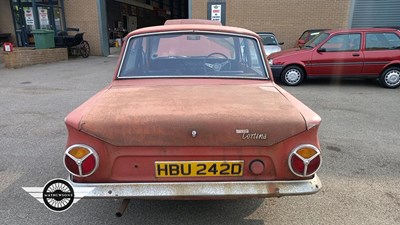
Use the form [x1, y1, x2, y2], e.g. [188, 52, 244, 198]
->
[289, 145, 321, 177]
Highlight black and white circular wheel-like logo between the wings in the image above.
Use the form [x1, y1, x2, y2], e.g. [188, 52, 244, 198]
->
[43, 179, 74, 212]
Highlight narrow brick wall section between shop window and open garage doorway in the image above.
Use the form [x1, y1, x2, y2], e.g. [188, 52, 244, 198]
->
[63, 0, 102, 55]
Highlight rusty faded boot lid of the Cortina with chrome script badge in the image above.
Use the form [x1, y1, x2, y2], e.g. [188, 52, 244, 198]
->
[79, 82, 306, 146]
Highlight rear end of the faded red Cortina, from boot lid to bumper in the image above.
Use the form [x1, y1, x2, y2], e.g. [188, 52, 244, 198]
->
[64, 80, 321, 199]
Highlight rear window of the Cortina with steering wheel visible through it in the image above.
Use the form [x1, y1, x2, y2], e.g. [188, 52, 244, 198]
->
[118, 32, 268, 79]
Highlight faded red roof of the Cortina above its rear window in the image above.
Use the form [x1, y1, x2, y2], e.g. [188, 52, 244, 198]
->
[126, 19, 257, 38]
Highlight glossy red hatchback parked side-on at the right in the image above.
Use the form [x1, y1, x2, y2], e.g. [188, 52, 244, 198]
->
[268, 28, 400, 88]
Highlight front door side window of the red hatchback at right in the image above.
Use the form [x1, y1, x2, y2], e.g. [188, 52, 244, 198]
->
[321, 34, 361, 52]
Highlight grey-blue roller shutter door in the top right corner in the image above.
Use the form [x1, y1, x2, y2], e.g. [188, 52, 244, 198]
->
[351, 0, 400, 28]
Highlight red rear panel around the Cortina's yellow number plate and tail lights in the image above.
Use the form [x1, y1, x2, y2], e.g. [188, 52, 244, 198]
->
[67, 123, 319, 183]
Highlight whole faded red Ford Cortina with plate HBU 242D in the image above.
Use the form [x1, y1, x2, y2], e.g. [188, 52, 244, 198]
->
[64, 19, 321, 213]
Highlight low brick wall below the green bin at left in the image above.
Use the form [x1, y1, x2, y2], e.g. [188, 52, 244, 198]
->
[1, 48, 68, 69]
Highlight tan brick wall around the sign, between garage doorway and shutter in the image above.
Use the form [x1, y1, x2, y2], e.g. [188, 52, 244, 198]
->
[192, 0, 351, 49]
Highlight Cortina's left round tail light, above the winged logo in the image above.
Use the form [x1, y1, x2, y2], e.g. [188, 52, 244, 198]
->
[64, 144, 99, 177]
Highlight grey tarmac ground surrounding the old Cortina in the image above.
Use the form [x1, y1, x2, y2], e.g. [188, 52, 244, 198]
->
[0, 56, 400, 225]
